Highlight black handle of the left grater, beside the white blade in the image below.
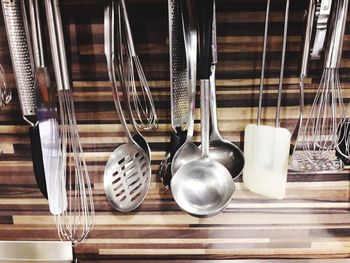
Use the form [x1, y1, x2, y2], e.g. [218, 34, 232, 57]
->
[29, 125, 47, 199]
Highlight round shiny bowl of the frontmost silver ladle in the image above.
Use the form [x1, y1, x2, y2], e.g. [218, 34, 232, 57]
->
[171, 157, 235, 217]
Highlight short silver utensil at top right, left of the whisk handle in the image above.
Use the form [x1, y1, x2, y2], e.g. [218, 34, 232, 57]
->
[311, 0, 332, 60]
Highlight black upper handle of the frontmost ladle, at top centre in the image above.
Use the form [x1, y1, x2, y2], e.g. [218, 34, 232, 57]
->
[197, 0, 214, 79]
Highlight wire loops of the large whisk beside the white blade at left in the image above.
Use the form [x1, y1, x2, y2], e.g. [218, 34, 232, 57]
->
[55, 90, 95, 246]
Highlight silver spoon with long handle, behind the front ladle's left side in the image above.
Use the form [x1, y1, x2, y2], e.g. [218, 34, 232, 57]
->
[171, 0, 201, 176]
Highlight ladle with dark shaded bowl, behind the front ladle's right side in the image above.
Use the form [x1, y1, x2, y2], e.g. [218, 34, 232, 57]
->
[209, 6, 244, 182]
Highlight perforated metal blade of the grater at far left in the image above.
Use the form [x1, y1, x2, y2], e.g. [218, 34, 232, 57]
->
[1, 0, 37, 126]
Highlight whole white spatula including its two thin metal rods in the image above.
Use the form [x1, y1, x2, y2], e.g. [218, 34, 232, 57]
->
[243, 0, 291, 199]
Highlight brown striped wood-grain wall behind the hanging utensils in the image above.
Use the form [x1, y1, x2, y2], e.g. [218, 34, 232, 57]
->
[0, 0, 350, 262]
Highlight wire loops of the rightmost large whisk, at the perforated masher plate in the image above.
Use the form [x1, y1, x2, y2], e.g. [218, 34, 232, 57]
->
[302, 68, 345, 171]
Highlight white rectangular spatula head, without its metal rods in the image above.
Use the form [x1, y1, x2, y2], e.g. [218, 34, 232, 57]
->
[243, 124, 291, 199]
